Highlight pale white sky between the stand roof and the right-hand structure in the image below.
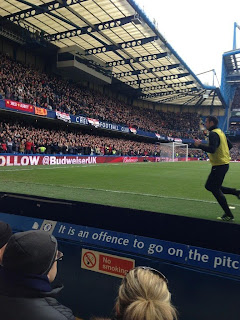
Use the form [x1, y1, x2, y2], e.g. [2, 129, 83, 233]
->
[135, 0, 240, 86]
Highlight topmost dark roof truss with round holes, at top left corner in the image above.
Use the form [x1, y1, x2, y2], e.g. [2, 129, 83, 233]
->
[1, 0, 87, 22]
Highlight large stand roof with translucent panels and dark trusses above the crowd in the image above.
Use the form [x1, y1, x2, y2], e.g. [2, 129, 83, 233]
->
[0, 0, 225, 106]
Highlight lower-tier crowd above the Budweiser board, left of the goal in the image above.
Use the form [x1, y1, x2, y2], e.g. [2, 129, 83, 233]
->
[0, 122, 160, 156]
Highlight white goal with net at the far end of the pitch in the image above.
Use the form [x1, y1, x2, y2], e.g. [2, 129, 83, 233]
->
[158, 142, 188, 162]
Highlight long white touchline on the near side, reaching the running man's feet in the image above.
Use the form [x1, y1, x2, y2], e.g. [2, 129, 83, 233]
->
[3, 181, 240, 207]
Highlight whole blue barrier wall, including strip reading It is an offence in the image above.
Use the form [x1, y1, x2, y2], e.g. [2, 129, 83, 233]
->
[0, 213, 240, 320]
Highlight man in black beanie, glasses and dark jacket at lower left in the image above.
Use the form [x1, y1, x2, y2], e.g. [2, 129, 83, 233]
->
[0, 230, 75, 320]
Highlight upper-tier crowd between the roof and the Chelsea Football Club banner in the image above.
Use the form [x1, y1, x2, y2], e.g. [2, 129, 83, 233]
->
[0, 54, 204, 139]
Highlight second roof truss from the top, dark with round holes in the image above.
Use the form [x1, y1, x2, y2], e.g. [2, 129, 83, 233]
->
[44, 16, 134, 41]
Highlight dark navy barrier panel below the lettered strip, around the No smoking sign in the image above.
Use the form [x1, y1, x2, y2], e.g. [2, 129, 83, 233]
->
[55, 242, 240, 320]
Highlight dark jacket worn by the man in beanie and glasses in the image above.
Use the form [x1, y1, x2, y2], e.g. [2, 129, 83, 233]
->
[0, 268, 75, 320]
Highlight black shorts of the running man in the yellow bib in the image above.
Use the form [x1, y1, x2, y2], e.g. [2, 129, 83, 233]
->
[205, 164, 229, 191]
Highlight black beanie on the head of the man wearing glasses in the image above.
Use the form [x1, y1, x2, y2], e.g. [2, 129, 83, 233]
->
[2, 230, 58, 275]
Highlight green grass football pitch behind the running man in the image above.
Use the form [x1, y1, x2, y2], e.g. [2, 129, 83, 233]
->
[0, 161, 240, 223]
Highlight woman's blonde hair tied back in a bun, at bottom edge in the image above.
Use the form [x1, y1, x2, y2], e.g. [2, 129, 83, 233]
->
[115, 267, 177, 320]
